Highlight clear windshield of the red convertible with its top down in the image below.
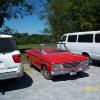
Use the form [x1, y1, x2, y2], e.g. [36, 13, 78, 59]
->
[40, 44, 68, 53]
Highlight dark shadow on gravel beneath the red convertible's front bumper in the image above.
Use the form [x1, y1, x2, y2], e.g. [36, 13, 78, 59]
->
[52, 72, 89, 82]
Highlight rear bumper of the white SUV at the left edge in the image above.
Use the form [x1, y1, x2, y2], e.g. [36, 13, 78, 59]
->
[0, 66, 24, 80]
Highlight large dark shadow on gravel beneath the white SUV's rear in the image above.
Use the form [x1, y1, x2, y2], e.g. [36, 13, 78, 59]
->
[0, 73, 33, 95]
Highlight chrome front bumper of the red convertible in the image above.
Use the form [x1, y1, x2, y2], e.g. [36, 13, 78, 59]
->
[51, 66, 89, 76]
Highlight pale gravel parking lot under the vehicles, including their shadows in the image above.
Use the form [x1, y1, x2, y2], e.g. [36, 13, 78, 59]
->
[0, 64, 100, 100]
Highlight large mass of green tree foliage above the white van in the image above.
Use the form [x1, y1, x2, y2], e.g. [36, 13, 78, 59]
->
[38, 0, 100, 40]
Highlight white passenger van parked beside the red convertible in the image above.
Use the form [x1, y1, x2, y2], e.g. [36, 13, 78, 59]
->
[57, 31, 100, 61]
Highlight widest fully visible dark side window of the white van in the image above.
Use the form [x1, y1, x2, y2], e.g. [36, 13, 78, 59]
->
[78, 34, 93, 43]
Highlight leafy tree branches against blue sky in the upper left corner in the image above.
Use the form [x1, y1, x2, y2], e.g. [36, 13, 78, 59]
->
[0, 0, 34, 27]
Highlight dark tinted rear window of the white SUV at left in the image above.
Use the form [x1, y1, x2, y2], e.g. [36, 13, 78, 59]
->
[0, 38, 17, 53]
